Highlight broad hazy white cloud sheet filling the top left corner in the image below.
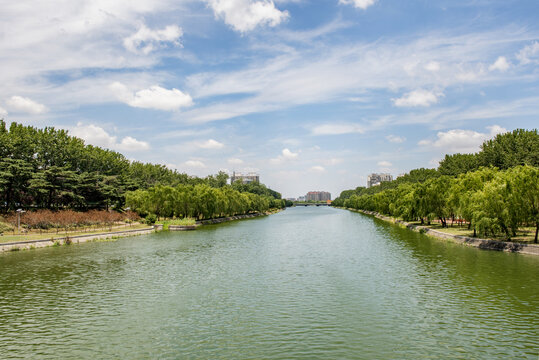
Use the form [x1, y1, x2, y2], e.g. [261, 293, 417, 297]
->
[0, 0, 181, 94]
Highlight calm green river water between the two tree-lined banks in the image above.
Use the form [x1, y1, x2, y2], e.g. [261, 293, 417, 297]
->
[0, 207, 539, 360]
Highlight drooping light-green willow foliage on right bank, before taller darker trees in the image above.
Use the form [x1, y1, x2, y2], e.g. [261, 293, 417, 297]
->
[343, 165, 539, 241]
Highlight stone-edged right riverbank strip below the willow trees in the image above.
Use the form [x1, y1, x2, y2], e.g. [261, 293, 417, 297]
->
[341, 208, 539, 256]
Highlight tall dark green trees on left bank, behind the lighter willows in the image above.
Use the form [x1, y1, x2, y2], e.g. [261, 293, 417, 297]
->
[0, 119, 281, 213]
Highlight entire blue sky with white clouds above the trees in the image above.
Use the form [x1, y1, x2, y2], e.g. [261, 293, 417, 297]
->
[0, 0, 539, 197]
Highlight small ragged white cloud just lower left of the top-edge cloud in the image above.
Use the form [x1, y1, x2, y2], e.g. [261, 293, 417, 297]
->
[123, 25, 183, 55]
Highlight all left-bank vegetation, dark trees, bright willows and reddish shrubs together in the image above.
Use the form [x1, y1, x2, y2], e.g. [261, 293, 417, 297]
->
[0, 120, 287, 250]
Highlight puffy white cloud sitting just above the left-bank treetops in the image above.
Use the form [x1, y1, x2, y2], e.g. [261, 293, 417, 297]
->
[69, 122, 150, 151]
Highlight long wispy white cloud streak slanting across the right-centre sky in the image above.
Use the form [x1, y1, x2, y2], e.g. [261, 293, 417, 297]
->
[178, 30, 536, 123]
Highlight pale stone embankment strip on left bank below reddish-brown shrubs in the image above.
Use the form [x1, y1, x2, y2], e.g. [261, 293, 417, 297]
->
[0, 227, 154, 252]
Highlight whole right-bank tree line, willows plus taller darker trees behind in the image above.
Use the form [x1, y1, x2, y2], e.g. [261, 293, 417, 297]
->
[333, 130, 539, 242]
